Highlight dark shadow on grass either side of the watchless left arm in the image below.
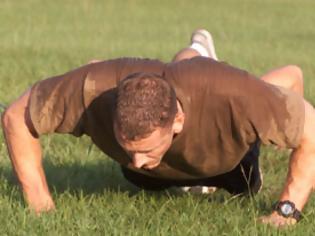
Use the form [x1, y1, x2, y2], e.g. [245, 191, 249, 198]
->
[0, 160, 139, 195]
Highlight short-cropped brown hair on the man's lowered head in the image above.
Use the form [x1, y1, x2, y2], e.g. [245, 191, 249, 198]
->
[114, 73, 177, 140]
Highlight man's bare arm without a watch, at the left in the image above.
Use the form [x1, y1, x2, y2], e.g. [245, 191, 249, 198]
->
[2, 91, 54, 212]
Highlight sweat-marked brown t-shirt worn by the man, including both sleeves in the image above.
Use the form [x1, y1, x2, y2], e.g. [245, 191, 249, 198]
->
[29, 57, 304, 179]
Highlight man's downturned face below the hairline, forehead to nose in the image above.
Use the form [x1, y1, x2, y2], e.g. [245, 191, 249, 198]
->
[115, 128, 174, 170]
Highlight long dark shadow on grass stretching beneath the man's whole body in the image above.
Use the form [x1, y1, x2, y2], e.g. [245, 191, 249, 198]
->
[0, 159, 264, 209]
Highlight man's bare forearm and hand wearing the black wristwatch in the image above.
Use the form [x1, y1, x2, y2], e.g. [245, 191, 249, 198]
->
[262, 101, 315, 226]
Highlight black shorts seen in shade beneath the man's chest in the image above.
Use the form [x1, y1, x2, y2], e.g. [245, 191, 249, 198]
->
[121, 142, 262, 194]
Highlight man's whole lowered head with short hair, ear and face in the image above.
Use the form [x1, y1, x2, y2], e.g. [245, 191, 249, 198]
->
[114, 73, 184, 169]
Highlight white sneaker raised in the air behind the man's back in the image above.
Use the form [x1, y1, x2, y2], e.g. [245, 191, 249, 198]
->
[191, 29, 218, 61]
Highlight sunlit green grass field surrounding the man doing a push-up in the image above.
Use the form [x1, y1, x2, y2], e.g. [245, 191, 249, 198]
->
[0, 0, 315, 235]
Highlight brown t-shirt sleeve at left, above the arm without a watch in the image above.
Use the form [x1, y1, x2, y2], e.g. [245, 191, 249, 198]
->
[29, 66, 88, 136]
